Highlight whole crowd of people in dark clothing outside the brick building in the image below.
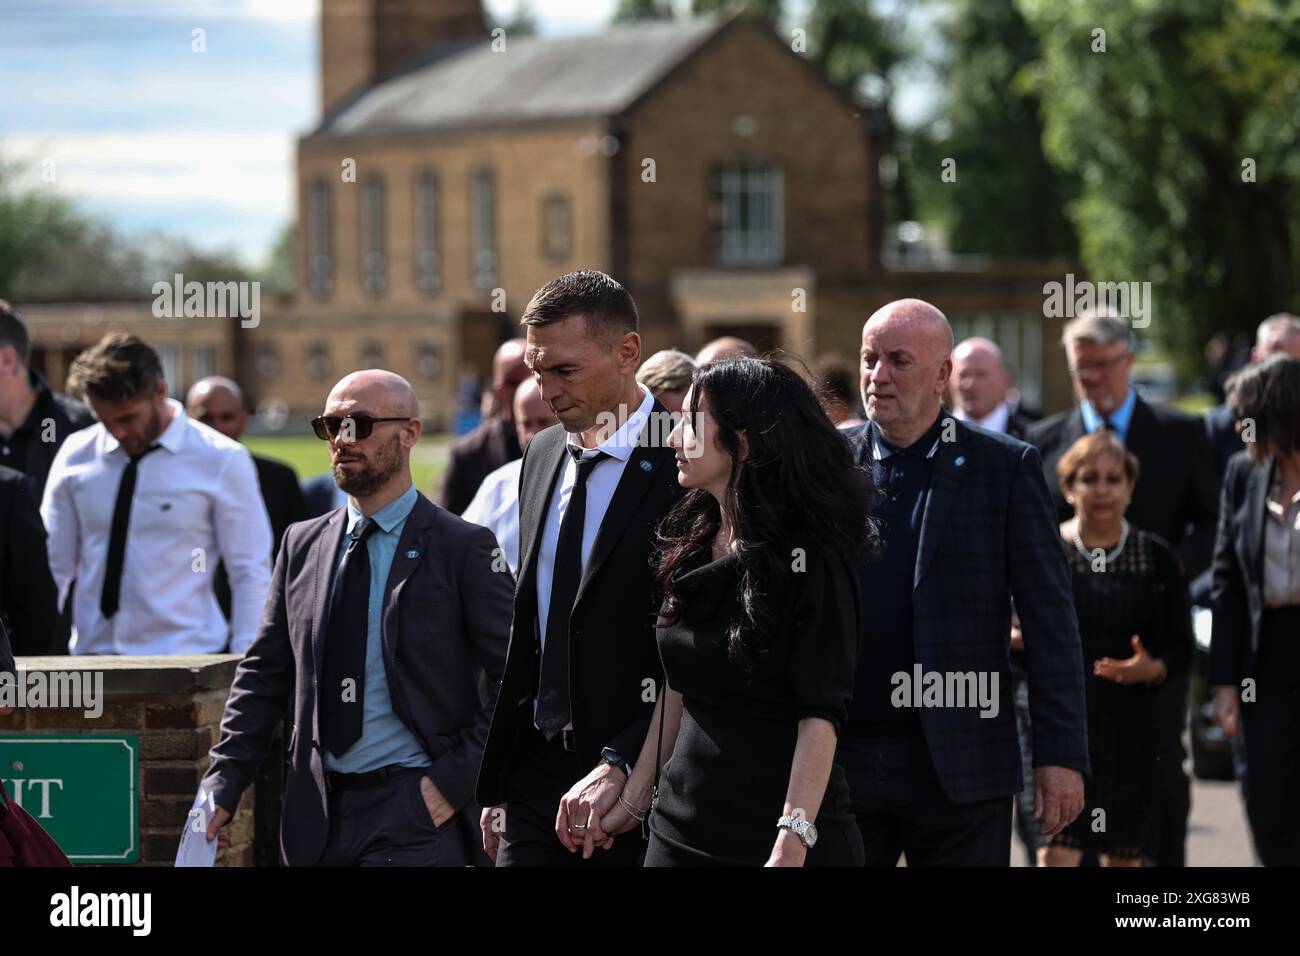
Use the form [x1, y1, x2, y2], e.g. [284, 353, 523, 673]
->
[0, 286, 1300, 866]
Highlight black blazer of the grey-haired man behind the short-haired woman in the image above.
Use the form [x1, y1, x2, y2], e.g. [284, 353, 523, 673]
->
[1026, 395, 1219, 579]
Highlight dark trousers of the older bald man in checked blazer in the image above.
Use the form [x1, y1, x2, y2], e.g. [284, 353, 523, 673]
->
[836, 735, 1011, 866]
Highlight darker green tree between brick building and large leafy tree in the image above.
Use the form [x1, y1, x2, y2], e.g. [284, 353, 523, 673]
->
[917, 0, 1079, 259]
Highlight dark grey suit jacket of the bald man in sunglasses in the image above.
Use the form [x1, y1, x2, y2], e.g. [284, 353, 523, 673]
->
[203, 496, 515, 866]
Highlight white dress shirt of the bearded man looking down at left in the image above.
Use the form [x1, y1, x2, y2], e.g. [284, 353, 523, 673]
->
[40, 399, 272, 654]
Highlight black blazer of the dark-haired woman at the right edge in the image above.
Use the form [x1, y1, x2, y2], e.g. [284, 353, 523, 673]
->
[1210, 451, 1274, 688]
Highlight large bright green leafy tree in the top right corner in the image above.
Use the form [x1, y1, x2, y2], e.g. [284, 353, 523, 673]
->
[1018, 0, 1300, 375]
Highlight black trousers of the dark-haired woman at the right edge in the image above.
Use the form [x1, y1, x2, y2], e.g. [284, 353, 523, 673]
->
[1242, 607, 1300, 866]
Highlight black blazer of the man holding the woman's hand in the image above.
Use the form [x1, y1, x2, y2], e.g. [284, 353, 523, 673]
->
[476, 401, 681, 806]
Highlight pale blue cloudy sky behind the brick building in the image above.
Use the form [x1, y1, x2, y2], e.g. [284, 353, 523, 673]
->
[0, 0, 925, 269]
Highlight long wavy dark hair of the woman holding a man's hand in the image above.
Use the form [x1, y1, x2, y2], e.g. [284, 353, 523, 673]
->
[655, 356, 878, 667]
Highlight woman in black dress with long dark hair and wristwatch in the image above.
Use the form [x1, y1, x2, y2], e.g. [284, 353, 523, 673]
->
[602, 359, 871, 866]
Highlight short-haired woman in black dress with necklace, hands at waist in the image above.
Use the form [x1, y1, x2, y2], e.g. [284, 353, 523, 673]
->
[1039, 431, 1192, 866]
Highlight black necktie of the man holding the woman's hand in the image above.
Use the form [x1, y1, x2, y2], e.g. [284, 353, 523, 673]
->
[537, 446, 608, 740]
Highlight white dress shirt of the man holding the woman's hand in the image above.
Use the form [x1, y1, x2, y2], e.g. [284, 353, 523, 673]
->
[537, 385, 654, 652]
